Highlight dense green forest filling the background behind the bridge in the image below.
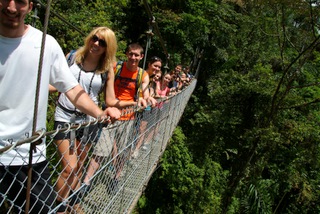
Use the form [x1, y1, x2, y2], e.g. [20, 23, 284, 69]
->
[29, 0, 320, 213]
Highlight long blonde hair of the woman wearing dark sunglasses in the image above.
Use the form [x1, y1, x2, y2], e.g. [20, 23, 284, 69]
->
[75, 27, 118, 73]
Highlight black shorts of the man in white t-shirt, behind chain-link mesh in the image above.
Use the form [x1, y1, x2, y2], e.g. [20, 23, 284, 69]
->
[0, 161, 56, 214]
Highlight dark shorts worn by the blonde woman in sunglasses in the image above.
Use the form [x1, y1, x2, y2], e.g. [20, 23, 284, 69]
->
[53, 121, 100, 144]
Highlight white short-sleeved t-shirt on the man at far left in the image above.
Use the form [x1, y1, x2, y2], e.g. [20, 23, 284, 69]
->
[0, 26, 78, 165]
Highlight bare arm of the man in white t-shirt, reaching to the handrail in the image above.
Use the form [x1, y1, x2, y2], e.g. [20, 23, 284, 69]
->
[65, 84, 120, 119]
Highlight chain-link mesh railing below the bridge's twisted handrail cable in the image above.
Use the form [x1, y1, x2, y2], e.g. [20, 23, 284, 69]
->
[0, 79, 197, 214]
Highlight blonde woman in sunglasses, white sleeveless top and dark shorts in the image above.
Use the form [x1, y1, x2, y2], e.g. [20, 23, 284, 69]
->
[54, 27, 120, 213]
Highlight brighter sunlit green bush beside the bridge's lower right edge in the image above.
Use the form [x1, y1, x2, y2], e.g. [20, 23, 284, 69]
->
[139, 128, 224, 213]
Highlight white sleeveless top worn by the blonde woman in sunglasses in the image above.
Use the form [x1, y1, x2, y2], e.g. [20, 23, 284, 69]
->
[54, 63, 102, 123]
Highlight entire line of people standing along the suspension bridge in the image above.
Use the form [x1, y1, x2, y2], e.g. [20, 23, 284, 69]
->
[0, 0, 191, 213]
